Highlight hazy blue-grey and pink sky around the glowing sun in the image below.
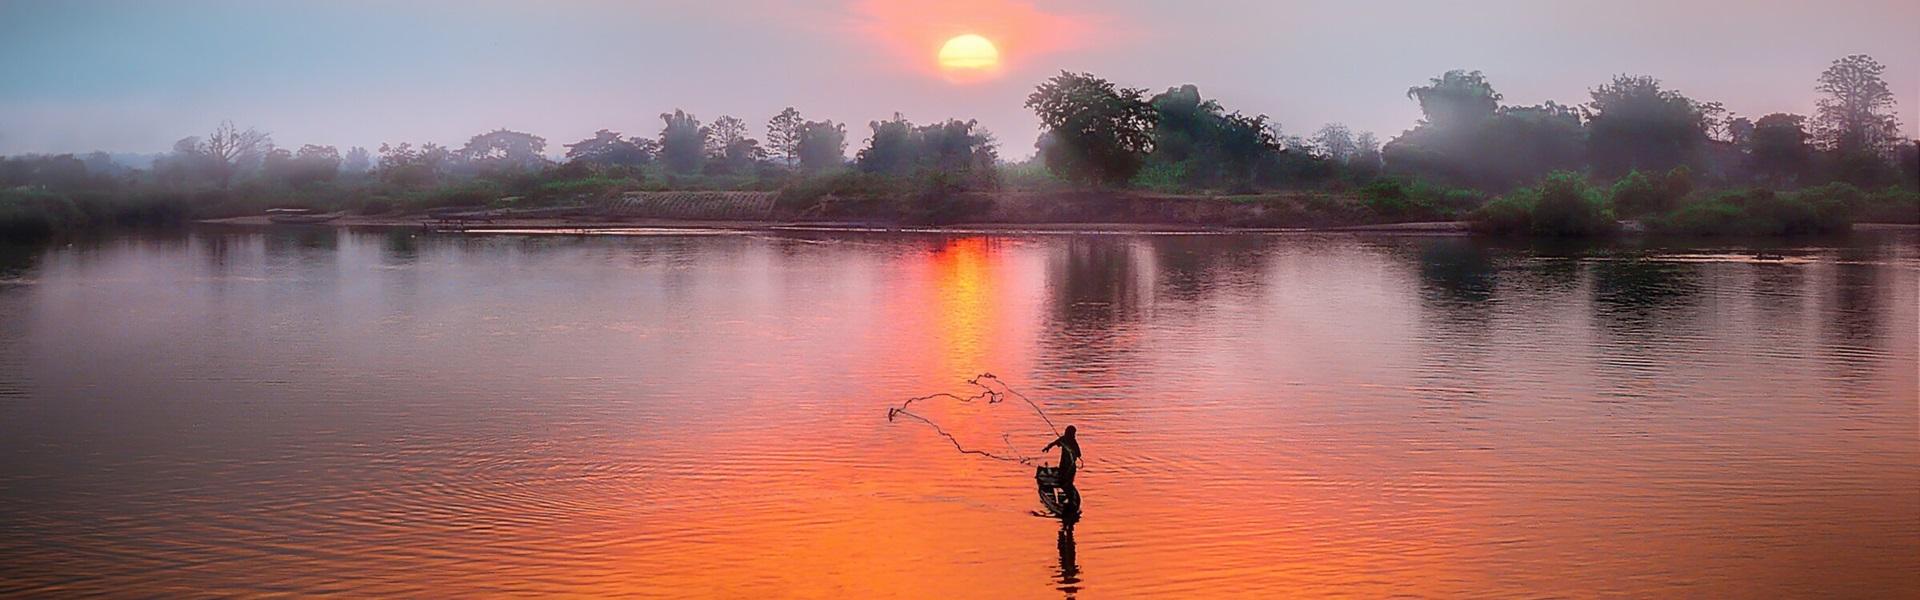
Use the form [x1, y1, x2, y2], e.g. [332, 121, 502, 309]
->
[0, 0, 1920, 158]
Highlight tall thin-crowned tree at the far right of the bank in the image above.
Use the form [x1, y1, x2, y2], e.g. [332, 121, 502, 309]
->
[1812, 54, 1901, 156]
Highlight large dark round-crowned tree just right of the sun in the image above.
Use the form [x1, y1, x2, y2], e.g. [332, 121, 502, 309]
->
[1025, 71, 1158, 185]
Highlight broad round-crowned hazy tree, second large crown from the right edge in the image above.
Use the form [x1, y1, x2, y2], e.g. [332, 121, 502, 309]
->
[1584, 75, 1722, 175]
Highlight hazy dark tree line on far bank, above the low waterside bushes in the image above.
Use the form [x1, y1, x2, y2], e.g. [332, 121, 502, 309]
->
[0, 56, 1920, 235]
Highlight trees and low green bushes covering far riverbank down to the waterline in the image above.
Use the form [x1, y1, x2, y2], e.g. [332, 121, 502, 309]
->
[0, 56, 1920, 237]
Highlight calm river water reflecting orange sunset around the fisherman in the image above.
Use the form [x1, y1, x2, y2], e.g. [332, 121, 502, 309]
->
[0, 231, 1920, 598]
